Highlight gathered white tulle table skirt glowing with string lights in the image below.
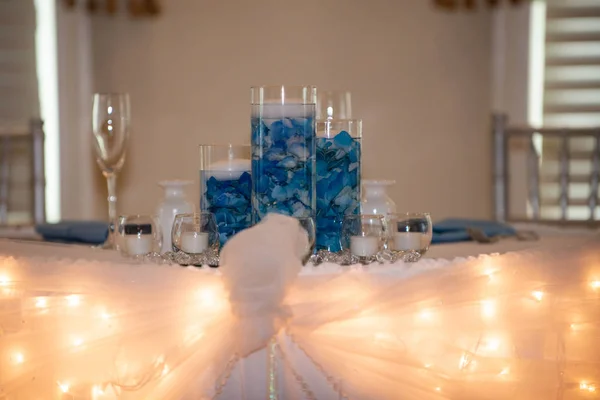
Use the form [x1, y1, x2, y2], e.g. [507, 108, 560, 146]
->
[0, 217, 600, 400]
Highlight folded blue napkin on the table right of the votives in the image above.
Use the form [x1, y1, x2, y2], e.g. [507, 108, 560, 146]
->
[432, 218, 516, 244]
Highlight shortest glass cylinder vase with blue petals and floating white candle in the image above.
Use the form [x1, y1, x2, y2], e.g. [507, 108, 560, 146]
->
[200, 144, 252, 247]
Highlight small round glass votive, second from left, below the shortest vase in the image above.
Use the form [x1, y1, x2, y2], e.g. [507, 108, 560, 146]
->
[171, 212, 219, 254]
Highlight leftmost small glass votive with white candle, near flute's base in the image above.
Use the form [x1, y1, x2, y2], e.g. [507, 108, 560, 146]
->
[117, 215, 162, 257]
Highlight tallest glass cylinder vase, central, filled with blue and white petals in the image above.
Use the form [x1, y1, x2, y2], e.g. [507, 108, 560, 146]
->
[251, 86, 316, 223]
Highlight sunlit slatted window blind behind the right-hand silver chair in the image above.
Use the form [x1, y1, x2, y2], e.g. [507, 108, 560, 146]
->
[540, 0, 600, 220]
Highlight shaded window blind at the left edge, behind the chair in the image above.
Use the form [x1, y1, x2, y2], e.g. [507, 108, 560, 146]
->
[0, 0, 39, 225]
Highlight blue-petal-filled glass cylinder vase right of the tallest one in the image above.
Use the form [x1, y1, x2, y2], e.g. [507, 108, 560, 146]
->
[316, 119, 362, 252]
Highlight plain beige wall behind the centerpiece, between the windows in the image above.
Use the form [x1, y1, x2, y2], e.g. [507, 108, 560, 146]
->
[84, 0, 492, 219]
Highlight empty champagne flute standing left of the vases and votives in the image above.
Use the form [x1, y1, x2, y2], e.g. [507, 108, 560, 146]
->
[92, 93, 131, 249]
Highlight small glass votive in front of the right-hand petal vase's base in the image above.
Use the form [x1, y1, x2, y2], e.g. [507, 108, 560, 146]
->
[342, 214, 386, 257]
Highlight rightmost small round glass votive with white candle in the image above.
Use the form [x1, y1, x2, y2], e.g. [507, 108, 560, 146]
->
[388, 213, 433, 256]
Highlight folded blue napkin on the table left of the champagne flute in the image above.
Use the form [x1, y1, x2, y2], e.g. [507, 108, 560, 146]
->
[35, 221, 108, 244]
